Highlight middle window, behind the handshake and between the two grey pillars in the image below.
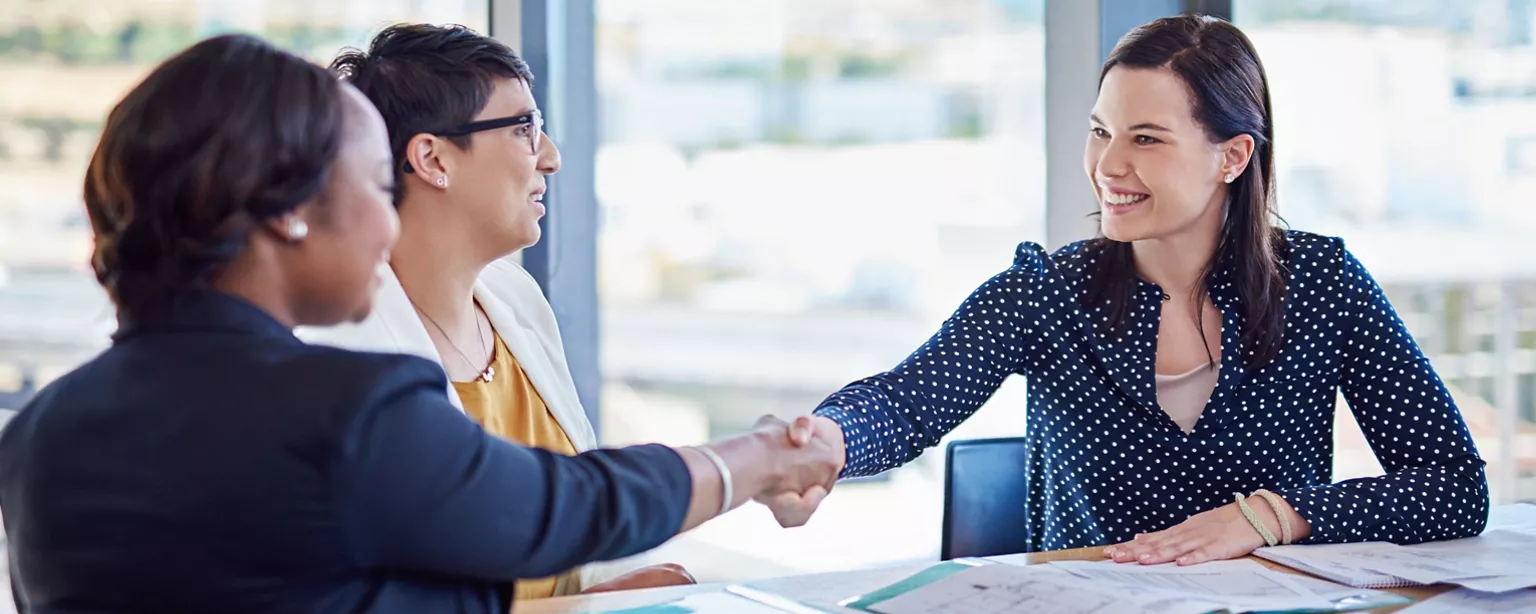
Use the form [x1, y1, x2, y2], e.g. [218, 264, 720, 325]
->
[596, 0, 1050, 580]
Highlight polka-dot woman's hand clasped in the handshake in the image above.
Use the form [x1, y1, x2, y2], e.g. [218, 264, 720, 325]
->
[753, 416, 846, 527]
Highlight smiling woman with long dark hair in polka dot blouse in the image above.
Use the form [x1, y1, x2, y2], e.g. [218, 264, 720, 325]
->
[766, 15, 1488, 563]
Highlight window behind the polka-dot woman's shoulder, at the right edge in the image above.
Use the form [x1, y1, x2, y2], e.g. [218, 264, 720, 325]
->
[1233, 0, 1536, 502]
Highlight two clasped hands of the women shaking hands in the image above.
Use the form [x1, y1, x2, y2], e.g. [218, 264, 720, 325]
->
[710, 416, 846, 527]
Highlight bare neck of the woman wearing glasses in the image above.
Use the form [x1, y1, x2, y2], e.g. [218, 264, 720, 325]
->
[390, 203, 490, 332]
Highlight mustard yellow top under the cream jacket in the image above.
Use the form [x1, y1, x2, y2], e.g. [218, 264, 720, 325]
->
[453, 335, 581, 602]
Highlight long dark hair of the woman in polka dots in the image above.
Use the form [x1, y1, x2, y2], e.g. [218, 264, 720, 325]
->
[1080, 15, 1289, 368]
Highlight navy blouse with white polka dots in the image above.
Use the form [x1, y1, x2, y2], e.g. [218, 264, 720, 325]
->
[817, 232, 1488, 550]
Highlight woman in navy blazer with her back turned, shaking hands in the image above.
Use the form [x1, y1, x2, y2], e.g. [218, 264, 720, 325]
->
[0, 35, 842, 614]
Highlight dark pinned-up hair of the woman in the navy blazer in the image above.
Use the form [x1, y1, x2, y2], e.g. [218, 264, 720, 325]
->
[84, 34, 344, 319]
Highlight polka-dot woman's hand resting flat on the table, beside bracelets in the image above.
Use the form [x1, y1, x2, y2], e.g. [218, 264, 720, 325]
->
[1104, 503, 1278, 565]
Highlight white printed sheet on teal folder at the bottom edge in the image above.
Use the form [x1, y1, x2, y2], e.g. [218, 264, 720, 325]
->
[862, 565, 1213, 614]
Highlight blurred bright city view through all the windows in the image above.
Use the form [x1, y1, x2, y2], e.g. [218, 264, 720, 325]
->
[0, 0, 1536, 598]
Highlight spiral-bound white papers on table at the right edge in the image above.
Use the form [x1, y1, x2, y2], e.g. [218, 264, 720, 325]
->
[1253, 528, 1536, 593]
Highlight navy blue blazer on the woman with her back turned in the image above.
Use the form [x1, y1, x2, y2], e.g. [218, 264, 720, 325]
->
[0, 293, 691, 614]
